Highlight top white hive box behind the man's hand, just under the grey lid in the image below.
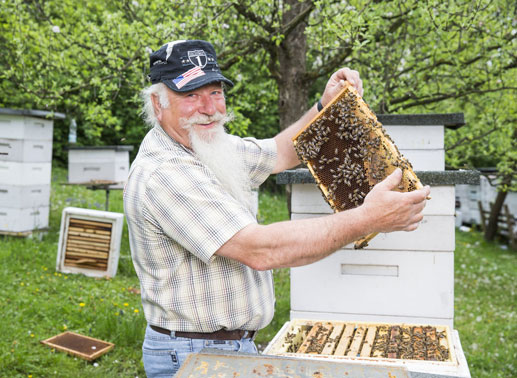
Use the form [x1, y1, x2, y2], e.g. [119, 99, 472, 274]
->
[291, 184, 455, 215]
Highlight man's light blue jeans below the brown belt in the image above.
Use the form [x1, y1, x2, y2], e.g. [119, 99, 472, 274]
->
[142, 325, 258, 378]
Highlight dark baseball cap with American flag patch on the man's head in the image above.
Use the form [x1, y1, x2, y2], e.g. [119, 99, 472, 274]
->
[149, 40, 233, 92]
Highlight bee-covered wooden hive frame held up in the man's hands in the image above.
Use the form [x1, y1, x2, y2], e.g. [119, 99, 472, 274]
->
[293, 82, 423, 248]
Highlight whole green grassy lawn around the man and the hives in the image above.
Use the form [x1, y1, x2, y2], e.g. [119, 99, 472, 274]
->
[0, 168, 517, 378]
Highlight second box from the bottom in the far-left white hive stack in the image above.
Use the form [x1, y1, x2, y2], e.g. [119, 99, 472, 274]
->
[0, 184, 50, 209]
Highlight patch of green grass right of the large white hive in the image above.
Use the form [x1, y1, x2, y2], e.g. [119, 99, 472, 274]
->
[454, 232, 517, 378]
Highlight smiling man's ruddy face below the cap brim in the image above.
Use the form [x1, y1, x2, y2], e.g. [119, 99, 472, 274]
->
[157, 83, 226, 148]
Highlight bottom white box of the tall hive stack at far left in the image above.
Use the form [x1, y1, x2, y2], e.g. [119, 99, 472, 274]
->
[0, 206, 49, 232]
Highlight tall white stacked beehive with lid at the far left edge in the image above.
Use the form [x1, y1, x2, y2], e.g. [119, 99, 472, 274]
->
[0, 109, 64, 233]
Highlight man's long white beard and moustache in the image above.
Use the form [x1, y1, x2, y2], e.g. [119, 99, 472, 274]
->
[180, 113, 252, 213]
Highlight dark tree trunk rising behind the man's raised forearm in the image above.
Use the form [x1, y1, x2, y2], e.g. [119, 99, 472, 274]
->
[277, 0, 310, 130]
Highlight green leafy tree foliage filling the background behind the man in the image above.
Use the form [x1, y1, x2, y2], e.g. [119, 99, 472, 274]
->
[0, 0, 517, 189]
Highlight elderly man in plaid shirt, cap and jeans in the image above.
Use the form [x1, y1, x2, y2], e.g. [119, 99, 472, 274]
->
[124, 40, 429, 377]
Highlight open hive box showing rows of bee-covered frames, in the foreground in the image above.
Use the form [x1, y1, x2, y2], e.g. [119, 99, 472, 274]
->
[264, 319, 469, 376]
